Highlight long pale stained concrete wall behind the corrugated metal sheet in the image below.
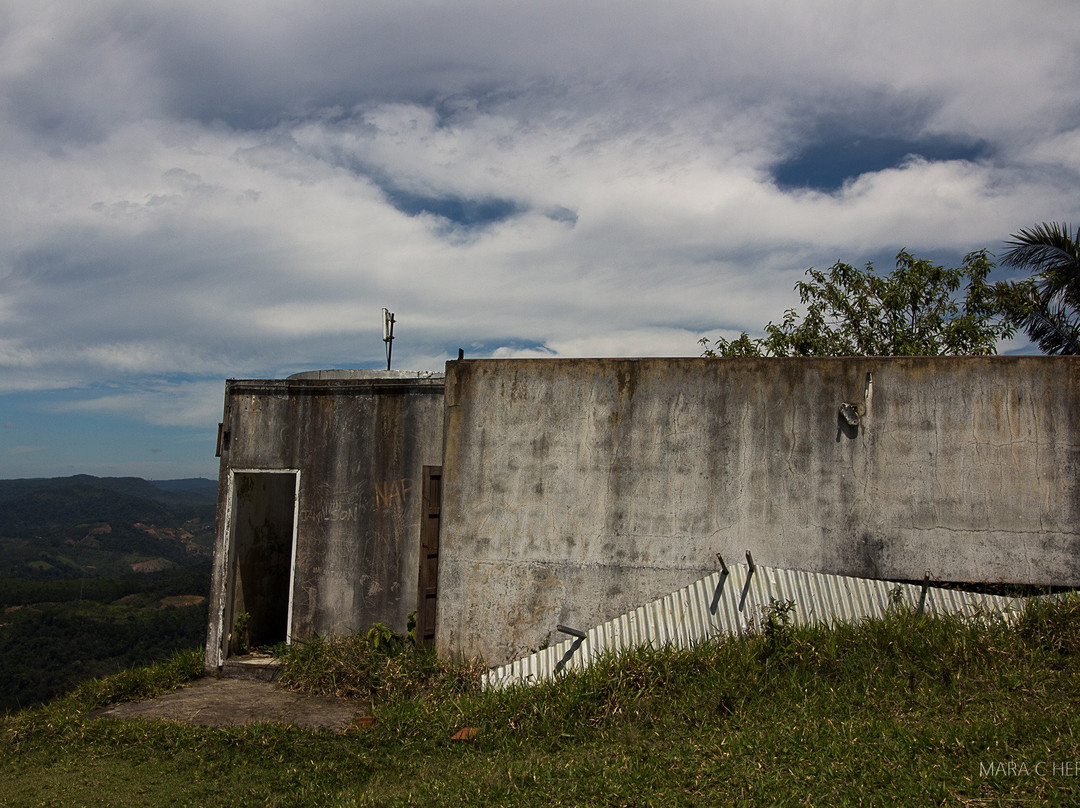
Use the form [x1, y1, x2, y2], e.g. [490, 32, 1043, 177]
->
[436, 358, 1080, 663]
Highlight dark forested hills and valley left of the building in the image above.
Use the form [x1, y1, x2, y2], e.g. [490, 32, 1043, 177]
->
[0, 475, 217, 713]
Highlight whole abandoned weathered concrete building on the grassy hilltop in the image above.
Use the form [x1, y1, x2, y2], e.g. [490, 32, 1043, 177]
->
[206, 356, 1080, 669]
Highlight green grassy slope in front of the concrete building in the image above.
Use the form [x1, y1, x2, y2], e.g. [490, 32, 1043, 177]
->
[0, 597, 1080, 806]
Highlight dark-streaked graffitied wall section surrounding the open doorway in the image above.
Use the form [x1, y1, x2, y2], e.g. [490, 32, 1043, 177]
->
[207, 372, 443, 666]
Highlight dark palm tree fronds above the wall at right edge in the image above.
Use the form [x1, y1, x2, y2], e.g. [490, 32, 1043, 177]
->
[1001, 221, 1080, 354]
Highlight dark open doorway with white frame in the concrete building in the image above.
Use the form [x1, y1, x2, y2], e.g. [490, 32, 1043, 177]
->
[221, 471, 296, 657]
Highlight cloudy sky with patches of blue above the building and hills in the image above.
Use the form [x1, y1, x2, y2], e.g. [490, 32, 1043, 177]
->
[0, 0, 1080, 479]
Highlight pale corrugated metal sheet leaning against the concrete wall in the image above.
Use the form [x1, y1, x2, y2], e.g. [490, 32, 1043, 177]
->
[485, 564, 1041, 688]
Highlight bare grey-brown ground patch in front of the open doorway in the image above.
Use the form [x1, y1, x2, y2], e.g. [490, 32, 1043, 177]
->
[93, 676, 364, 732]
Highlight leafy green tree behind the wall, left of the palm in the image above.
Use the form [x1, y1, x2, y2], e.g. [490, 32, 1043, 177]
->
[700, 250, 1026, 356]
